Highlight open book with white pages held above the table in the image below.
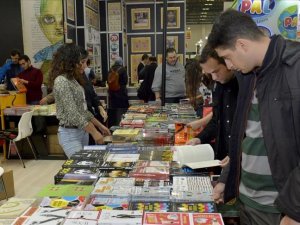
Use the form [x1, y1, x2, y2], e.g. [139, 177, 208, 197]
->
[173, 144, 220, 169]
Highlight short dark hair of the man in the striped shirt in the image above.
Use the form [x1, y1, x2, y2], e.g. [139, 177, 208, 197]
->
[208, 9, 265, 49]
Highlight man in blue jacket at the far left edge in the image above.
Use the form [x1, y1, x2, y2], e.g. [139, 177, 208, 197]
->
[0, 50, 23, 91]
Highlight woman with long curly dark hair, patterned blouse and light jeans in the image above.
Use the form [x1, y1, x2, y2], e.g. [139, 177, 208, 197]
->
[49, 44, 106, 158]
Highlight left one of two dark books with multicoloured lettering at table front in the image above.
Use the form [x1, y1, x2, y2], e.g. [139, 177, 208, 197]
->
[129, 202, 172, 212]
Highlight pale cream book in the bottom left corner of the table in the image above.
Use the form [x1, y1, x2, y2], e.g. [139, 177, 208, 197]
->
[0, 198, 36, 219]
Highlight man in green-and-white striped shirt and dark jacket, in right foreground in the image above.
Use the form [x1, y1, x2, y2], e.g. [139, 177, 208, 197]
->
[208, 10, 300, 225]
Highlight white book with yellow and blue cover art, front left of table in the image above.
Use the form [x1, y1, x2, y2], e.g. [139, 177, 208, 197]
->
[40, 196, 86, 210]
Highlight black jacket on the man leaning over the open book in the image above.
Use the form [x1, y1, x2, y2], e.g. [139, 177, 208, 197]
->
[197, 77, 239, 160]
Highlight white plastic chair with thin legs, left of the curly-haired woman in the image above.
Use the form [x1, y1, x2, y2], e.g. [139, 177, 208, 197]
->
[7, 111, 37, 168]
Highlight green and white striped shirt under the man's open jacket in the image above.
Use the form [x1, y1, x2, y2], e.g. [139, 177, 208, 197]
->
[239, 91, 279, 213]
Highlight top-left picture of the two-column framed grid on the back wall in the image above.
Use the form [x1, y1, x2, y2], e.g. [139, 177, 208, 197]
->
[131, 8, 151, 30]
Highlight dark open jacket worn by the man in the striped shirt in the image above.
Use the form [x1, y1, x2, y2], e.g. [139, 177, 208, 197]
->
[224, 36, 300, 222]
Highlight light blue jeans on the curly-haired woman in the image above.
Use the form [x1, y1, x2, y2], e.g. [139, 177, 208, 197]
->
[57, 127, 89, 158]
